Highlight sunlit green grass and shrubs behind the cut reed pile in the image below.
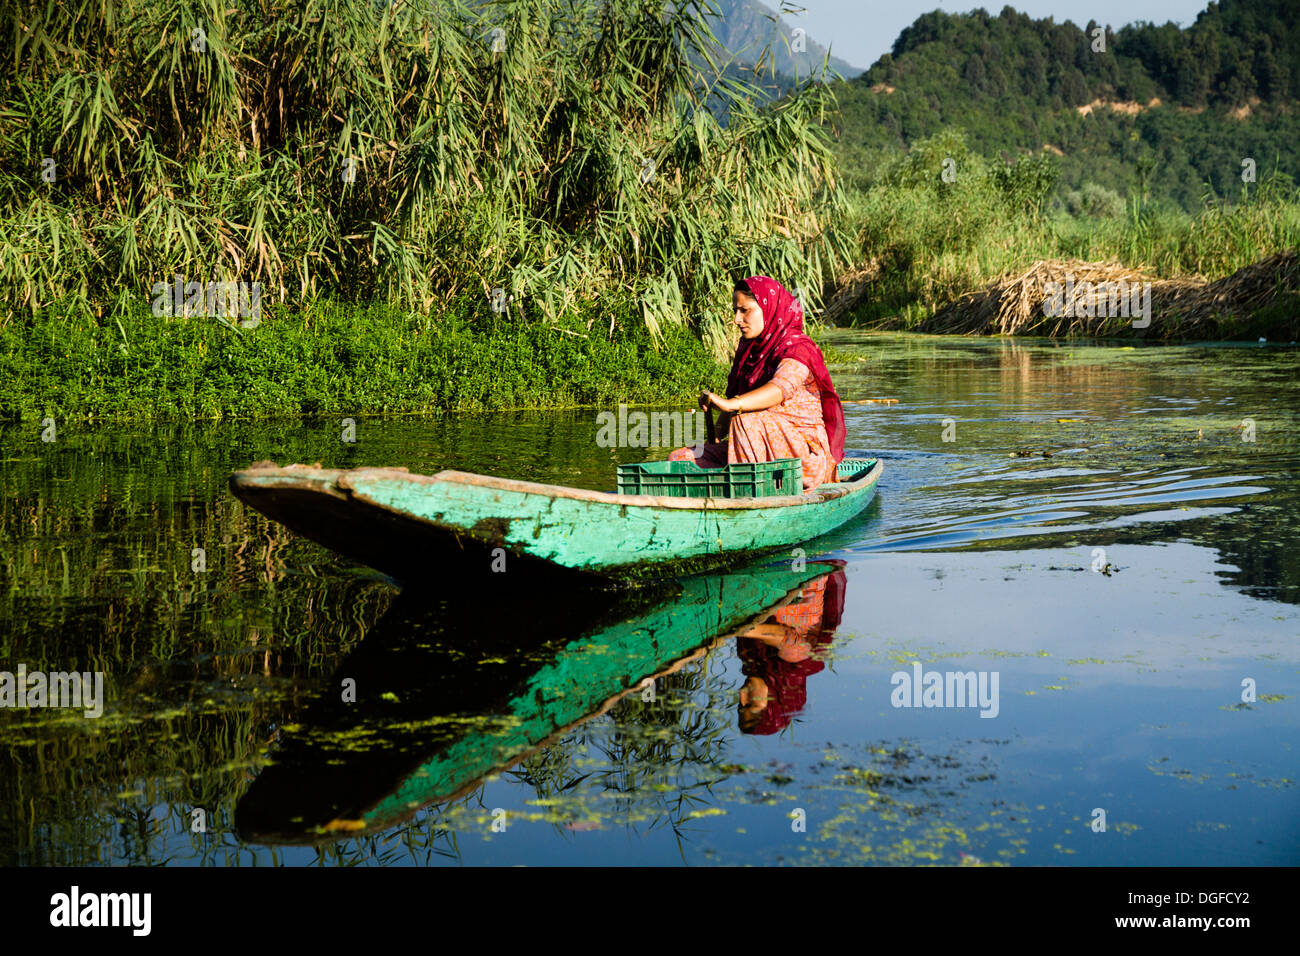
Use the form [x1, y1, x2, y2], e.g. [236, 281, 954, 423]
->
[846, 131, 1300, 326]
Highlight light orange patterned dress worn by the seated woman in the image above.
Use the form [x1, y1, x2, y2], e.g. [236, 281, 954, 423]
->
[668, 359, 836, 492]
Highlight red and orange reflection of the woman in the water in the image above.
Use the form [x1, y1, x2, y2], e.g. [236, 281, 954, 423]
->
[738, 562, 845, 734]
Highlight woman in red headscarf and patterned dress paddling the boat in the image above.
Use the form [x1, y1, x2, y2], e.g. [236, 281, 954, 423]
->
[670, 276, 845, 490]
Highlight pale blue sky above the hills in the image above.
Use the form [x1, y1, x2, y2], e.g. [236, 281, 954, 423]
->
[780, 0, 1209, 69]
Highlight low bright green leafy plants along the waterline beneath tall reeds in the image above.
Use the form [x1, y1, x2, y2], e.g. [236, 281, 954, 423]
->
[0, 299, 724, 423]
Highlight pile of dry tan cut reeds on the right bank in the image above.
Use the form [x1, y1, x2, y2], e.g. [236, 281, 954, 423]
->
[917, 248, 1300, 338]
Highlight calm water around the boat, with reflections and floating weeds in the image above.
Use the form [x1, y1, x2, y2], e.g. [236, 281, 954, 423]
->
[0, 333, 1300, 865]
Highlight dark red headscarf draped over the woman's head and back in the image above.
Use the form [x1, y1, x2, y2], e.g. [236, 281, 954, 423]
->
[727, 276, 845, 462]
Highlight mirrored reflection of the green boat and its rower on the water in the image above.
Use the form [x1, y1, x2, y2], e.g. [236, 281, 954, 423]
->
[235, 562, 844, 843]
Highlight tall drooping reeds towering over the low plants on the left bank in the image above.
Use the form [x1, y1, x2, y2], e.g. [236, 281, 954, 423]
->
[0, 0, 850, 345]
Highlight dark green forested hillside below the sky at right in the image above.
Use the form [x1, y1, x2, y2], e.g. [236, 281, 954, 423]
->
[833, 0, 1300, 209]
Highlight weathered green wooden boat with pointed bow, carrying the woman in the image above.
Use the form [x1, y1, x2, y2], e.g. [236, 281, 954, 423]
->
[230, 458, 881, 587]
